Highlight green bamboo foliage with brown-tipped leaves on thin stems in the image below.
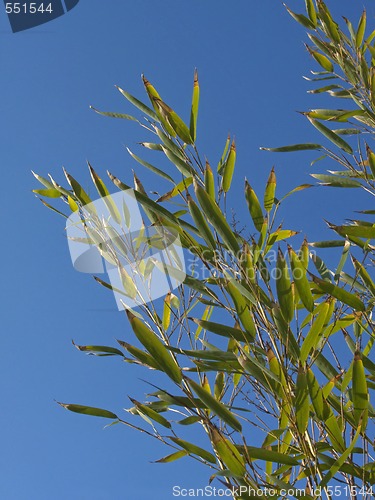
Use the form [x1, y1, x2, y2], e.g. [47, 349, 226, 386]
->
[34, 0, 375, 498]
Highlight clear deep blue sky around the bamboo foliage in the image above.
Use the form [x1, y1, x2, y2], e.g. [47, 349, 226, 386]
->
[0, 0, 375, 500]
